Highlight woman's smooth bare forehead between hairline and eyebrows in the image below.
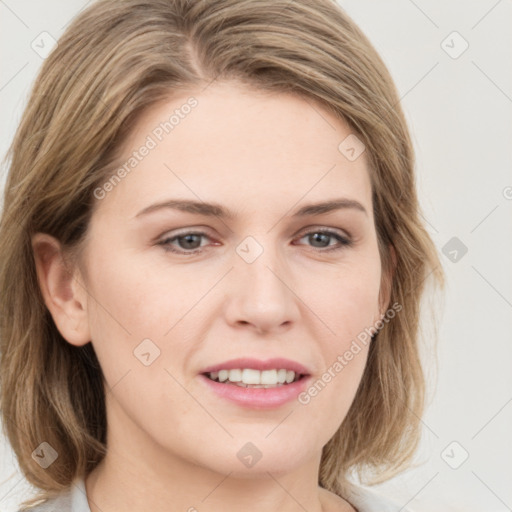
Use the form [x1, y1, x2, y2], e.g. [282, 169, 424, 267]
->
[95, 83, 371, 220]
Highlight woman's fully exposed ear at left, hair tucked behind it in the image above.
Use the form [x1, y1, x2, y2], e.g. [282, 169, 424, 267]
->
[32, 233, 90, 346]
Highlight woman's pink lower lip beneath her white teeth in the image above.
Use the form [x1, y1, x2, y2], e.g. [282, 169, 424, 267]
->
[199, 375, 309, 409]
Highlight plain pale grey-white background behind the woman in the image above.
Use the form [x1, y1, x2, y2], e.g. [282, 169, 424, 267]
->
[0, 0, 512, 512]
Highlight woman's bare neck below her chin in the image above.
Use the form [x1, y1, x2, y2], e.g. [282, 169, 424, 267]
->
[86, 452, 336, 512]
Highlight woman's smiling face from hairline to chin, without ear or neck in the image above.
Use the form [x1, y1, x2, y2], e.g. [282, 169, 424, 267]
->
[73, 83, 381, 476]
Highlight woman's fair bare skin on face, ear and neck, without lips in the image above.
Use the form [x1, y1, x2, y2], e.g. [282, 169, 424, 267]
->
[33, 83, 387, 512]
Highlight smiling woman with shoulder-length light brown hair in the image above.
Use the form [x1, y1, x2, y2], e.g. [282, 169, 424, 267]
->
[0, 0, 442, 512]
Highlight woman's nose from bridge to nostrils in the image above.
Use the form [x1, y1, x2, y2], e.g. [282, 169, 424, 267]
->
[225, 244, 300, 334]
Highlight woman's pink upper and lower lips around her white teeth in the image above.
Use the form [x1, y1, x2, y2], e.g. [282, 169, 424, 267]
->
[199, 358, 311, 409]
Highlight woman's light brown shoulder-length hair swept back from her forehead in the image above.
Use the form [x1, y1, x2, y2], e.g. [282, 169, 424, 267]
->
[0, 0, 443, 504]
